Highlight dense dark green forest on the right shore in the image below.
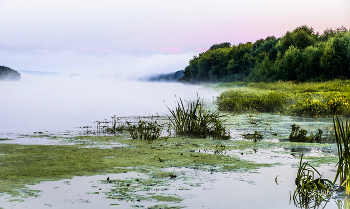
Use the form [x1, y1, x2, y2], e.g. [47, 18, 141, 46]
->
[179, 25, 350, 83]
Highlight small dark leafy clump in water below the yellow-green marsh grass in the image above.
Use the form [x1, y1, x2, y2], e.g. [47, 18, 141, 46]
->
[288, 124, 323, 143]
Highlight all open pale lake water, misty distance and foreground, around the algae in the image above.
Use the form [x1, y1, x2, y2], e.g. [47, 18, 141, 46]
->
[0, 77, 344, 209]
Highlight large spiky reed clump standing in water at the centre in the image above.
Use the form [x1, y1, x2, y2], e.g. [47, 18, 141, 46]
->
[167, 97, 230, 140]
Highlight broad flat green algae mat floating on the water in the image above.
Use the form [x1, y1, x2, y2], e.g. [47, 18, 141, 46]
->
[0, 135, 272, 196]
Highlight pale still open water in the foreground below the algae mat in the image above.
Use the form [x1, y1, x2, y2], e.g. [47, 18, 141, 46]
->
[0, 164, 337, 209]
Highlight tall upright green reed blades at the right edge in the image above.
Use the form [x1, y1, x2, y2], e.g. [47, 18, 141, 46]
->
[333, 117, 350, 195]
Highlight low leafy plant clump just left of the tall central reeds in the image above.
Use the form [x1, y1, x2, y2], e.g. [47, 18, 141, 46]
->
[126, 120, 164, 141]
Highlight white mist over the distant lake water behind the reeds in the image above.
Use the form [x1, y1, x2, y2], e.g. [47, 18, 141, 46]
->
[0, 74, 218, 133]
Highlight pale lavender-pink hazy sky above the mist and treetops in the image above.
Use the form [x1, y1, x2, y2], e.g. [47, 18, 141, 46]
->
[0, 0, 350, 79]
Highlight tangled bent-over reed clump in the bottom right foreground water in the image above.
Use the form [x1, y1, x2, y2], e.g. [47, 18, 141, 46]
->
[293, 154, 334, 208]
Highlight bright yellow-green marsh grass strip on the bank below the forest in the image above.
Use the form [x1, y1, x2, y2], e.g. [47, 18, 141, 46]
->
[218, 80, 350, 117]
